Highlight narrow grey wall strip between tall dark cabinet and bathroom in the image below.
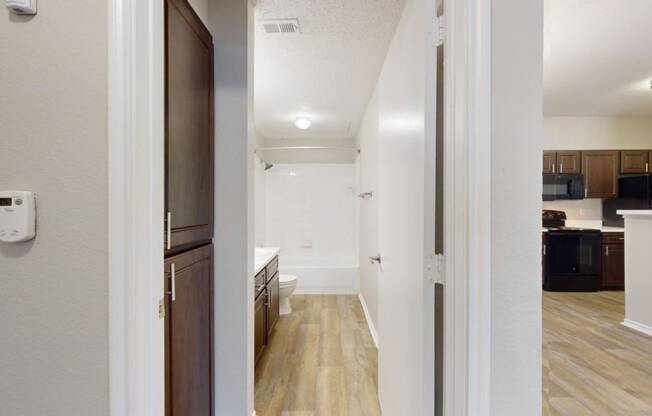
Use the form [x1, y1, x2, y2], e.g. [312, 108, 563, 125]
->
[208, 0, 255, 416]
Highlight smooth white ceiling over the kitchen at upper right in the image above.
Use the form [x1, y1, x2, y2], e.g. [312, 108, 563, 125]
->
[544, 0, 652, 116]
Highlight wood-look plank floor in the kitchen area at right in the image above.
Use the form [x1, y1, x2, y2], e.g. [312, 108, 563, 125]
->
[543, 292, 652, 416]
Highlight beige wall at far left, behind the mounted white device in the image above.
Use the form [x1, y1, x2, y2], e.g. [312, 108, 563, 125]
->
[0, 0, 109, 416]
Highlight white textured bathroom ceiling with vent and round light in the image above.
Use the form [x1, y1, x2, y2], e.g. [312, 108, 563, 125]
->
[254, 0, 404, 139]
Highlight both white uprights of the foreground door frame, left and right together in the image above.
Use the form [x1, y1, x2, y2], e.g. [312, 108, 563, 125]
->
[108, 0, 491, 416]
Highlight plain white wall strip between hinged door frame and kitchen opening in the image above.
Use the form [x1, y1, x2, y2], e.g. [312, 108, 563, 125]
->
[490, 0, 543, 416]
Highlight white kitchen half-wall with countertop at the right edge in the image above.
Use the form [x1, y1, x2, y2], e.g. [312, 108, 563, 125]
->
[618, 210, 652, 336]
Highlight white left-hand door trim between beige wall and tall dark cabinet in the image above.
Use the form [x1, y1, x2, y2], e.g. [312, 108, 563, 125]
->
[108, 0, 165, 416]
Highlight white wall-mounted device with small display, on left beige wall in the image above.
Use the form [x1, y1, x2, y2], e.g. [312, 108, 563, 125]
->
[0, 191, 36, 243]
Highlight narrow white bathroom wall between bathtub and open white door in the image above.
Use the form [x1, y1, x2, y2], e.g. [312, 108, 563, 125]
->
[356, 91, 379, 330]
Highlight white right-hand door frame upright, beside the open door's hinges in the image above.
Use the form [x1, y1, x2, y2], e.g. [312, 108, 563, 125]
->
[444, 0, 491, 416]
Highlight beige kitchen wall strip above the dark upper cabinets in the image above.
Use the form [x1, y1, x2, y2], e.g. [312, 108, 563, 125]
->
[543, 117, 652, 150]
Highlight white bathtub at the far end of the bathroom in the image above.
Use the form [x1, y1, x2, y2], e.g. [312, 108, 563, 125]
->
[279, 255, 360, 295]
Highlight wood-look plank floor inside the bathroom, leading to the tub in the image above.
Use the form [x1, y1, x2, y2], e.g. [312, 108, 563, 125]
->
[255, 295, 380, 416]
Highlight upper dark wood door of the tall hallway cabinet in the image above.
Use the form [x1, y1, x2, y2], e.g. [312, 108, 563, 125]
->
[165, 0, 214, 251]
